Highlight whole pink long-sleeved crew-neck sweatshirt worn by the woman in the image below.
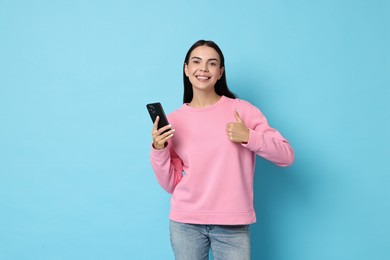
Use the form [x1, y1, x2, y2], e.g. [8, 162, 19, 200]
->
[150, 96, 294, 225]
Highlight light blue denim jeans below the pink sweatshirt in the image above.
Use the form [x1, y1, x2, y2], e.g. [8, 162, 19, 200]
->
[170, 220, 250, 260]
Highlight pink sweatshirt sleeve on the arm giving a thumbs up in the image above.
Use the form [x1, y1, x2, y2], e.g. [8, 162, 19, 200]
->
[243, 106, 294, 166]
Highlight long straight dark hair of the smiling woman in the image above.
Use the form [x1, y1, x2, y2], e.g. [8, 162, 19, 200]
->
[183, 40, 236, 103]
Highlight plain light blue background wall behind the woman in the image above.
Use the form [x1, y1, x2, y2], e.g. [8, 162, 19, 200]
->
[0, 0, 390, 260]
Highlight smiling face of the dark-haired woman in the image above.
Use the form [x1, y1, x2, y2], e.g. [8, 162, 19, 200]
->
[184, 46, 224, 94]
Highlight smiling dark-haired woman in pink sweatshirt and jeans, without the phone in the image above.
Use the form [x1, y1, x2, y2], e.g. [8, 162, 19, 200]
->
[150, 40, 294, 260]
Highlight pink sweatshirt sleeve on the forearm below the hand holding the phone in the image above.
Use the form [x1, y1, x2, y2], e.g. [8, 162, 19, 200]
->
[150, 143, 183, 193]
